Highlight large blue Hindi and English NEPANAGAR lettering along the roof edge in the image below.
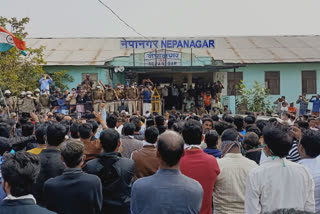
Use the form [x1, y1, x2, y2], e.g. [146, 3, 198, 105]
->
[120, 39, 214, 49]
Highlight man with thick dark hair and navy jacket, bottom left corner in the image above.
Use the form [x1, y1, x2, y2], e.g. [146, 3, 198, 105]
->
[0, 151, 54, 214]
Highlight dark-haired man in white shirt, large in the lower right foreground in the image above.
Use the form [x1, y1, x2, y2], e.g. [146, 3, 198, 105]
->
[245, 124, 315, 214]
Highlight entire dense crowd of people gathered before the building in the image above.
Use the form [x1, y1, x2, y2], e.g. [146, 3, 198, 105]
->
[0, 75, 320, 214]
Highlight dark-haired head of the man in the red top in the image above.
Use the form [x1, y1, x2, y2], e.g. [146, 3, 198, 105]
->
[182, 119, 202, 145]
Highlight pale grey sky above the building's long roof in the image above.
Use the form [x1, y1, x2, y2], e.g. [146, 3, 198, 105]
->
[0, 0, 320, 37]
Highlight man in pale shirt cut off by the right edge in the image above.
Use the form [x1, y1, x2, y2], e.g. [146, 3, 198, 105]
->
[298, 130, 320, 212]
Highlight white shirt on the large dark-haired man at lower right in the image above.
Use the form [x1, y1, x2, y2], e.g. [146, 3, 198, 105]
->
[245, 157, 315, 214]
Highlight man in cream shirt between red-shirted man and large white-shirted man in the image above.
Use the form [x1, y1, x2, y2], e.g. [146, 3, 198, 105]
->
[213, 128, 258, 214]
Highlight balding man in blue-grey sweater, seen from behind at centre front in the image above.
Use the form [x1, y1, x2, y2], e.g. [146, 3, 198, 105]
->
[131, 131, 203, 214]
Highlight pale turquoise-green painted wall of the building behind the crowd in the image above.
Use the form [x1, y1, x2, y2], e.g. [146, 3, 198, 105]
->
[44, 61, 320, 112]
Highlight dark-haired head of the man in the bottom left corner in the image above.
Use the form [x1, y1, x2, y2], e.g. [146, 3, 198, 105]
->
[1, 151, 40, 197]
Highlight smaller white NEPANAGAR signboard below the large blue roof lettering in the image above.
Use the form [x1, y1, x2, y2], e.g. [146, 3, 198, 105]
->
[144, 50, 181, 66]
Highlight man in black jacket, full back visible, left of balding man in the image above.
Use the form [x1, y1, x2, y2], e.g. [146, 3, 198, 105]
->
[85, 129, 134, 214]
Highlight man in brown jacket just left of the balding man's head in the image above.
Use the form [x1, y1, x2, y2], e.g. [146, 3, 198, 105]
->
[132, 127, 160, 180]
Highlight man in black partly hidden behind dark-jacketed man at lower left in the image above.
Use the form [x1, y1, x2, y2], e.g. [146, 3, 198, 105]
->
[33, 122, 67, 205]
